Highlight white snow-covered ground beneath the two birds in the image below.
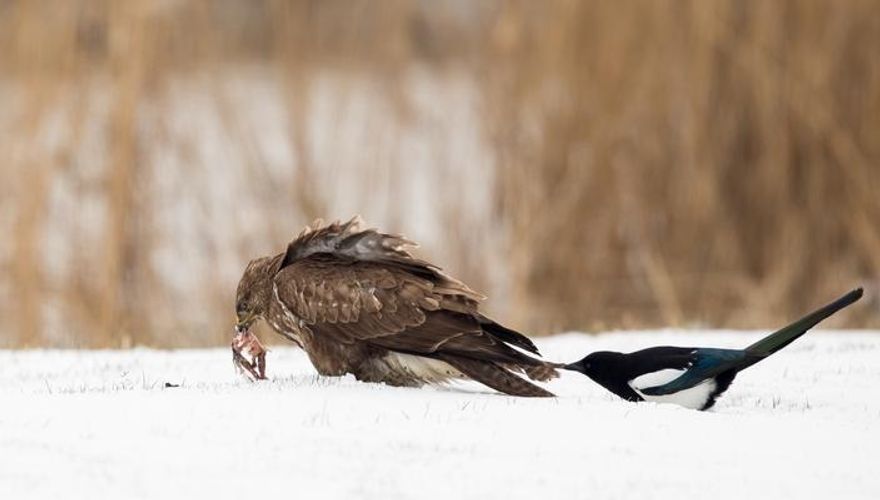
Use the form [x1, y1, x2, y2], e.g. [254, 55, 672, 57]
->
[0, 331, 880, 500]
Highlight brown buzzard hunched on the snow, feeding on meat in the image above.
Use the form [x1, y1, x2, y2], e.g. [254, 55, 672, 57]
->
[233, 217, 561, 397]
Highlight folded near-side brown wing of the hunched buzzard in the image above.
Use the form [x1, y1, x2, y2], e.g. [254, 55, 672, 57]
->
[274, 254, 543, 366]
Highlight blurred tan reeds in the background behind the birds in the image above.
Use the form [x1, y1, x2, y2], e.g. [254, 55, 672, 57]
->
[0, 0, 880, 347]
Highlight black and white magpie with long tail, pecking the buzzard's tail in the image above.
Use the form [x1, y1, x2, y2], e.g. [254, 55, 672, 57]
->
[563, 288, 862, 410]
